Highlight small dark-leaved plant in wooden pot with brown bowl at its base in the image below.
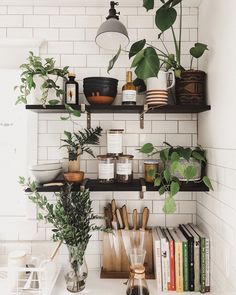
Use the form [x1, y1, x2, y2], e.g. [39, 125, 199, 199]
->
[61, 127, 102, 182]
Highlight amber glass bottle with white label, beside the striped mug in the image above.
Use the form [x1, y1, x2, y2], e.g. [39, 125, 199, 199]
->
[122, 71, 136, 105]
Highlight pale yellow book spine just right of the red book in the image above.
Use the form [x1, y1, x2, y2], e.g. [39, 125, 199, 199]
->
[175, 243, 183, 292]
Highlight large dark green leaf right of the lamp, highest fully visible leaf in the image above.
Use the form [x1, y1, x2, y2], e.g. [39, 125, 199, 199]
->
[155, 6, 177, 32]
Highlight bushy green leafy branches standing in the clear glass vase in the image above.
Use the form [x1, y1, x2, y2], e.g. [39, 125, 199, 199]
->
[19, 177, 106, 264]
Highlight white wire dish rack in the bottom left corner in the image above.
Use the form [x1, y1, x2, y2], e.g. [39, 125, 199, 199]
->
[0, 255, 61, 295]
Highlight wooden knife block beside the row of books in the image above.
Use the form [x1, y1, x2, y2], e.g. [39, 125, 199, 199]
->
[100, 229, 155, 279]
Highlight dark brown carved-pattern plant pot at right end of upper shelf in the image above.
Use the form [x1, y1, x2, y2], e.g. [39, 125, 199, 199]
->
[175, 70, 206, 105]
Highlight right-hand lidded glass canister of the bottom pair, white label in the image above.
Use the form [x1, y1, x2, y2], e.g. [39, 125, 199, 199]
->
[116, 155, 134, 183]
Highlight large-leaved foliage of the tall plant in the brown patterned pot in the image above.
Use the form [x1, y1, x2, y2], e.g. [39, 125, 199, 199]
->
[108, 0, 208, 80]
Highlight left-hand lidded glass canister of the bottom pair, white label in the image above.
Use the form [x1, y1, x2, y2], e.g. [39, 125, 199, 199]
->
[97, 155, 115, 183]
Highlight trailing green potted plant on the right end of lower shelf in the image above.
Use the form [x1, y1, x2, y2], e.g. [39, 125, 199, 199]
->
[139, 142, 213, 214]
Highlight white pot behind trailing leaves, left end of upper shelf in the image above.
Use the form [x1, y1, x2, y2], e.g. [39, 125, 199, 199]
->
[27, 75, 64, 105]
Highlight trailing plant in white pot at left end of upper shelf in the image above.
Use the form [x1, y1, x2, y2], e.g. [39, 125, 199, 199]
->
[15, 51, 80, 120]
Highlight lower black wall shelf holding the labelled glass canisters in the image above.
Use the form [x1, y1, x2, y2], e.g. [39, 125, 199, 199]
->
[26, 179, 209, 192]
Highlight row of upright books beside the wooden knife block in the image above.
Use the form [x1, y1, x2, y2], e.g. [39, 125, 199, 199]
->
[153, 224, 210, 293]
